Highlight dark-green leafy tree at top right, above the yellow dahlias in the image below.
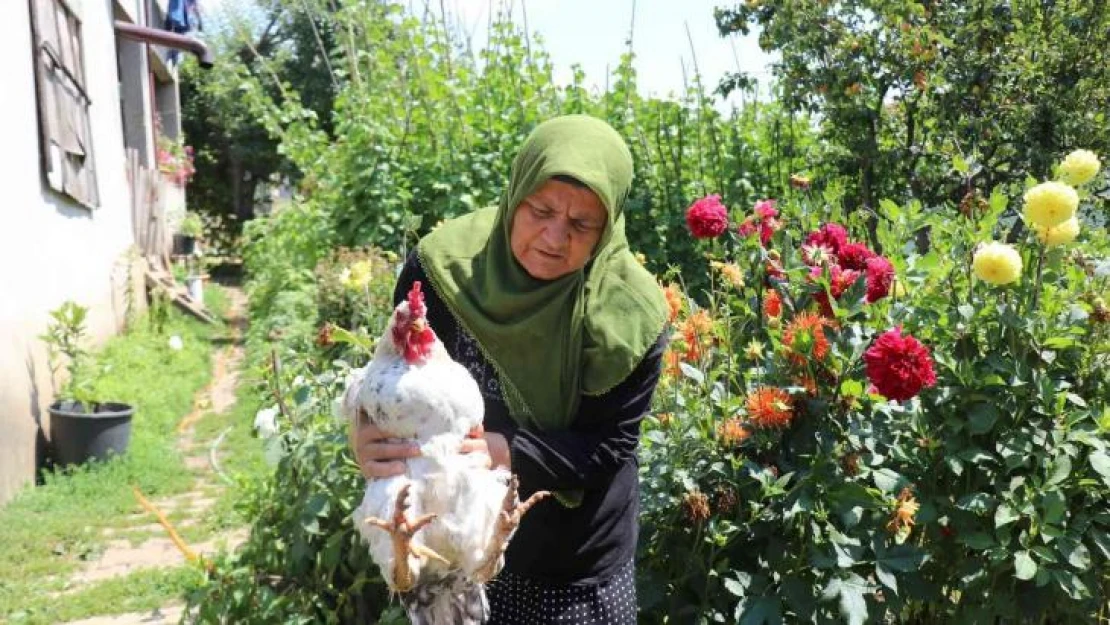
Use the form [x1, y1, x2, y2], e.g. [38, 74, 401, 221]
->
[716, 0, 1110, 229]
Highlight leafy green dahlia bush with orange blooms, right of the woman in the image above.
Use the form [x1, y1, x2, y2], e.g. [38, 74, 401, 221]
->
[638, 167, 1110, 623]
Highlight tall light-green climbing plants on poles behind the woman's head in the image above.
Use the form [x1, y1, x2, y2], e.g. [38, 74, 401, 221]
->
[201, 2, 815, 293]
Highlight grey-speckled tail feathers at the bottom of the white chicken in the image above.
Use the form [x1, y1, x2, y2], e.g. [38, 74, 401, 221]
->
[401, 573, 490, 625]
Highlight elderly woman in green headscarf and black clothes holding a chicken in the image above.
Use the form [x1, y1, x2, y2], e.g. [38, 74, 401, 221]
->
[354, 115, 666, 624]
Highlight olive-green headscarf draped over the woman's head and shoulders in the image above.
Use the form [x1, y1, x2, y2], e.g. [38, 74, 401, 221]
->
[417, 115, 667, 430]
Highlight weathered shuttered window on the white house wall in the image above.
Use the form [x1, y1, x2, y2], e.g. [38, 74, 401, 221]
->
[29, 0, 99, 209]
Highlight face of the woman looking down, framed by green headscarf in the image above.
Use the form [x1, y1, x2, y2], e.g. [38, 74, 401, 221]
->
[509, 180, 608, 280]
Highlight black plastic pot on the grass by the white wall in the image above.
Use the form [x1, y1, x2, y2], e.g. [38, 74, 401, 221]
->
[49, 402, 134, 465]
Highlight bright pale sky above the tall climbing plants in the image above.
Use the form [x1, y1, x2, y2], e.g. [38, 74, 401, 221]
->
[201, 0, 770, 110]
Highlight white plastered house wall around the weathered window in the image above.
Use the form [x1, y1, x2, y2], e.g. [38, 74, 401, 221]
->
[0, 0, 162, 503]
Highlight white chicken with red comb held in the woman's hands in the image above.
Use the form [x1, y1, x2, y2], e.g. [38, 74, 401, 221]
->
[343, 282, 547, 625]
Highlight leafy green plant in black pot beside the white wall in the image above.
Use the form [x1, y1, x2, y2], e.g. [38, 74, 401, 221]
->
[41, 302, 134, 465]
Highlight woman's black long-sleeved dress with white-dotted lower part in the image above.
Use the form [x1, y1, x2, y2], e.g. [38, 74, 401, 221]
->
[394, 253, 666, 625]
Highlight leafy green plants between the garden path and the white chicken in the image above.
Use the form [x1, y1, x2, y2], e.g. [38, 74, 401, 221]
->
[189, 250, 403, 623]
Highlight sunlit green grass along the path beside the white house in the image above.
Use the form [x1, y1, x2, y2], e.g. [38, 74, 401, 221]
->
[0, 288, 234, 623]
